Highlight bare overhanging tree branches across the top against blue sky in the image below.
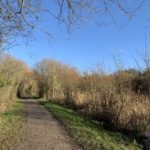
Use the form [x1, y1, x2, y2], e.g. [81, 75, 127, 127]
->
[0, 0, 145, 44]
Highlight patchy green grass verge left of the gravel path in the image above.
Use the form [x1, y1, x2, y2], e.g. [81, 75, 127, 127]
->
[0, 101, 24, 150]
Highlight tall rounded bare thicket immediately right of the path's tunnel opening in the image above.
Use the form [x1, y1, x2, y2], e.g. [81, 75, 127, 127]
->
[35, 60, 79, 103]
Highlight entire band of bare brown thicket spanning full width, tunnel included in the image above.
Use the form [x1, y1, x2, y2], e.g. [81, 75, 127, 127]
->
[0, 56, 150, 134]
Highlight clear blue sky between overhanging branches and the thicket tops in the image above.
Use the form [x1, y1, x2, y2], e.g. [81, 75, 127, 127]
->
[9, 0, 150, 71]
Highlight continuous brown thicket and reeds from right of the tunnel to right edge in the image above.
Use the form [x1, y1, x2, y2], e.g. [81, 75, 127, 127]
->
[35, 60, 150, 131]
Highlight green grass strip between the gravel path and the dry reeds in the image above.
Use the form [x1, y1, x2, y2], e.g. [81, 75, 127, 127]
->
[40, 101, 140, 150]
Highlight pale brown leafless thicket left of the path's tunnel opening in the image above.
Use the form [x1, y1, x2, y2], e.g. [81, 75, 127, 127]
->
[0, 54, 27, 112]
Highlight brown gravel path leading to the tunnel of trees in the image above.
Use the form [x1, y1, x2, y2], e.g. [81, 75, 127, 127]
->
[16, 99, 81, 150]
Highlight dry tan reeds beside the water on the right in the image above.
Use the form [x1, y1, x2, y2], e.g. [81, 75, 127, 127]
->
[75, 74, 150, 131]
